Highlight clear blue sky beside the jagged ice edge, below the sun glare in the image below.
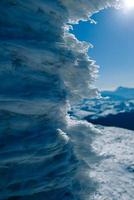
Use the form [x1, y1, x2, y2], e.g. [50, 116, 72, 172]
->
[73, 9, 134, 90]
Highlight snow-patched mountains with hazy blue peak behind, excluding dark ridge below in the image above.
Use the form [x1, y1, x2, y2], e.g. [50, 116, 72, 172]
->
[70, 87, 134, 127]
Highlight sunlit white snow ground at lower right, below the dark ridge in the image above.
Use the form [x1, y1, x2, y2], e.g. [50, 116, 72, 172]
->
[90, 127, 134, 200]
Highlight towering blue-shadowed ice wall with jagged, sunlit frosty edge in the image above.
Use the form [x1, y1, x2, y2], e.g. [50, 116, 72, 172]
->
[0, 0, 122, 200]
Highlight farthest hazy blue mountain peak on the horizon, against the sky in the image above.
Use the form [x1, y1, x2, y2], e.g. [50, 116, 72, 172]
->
[101, 87, 134, 100]
